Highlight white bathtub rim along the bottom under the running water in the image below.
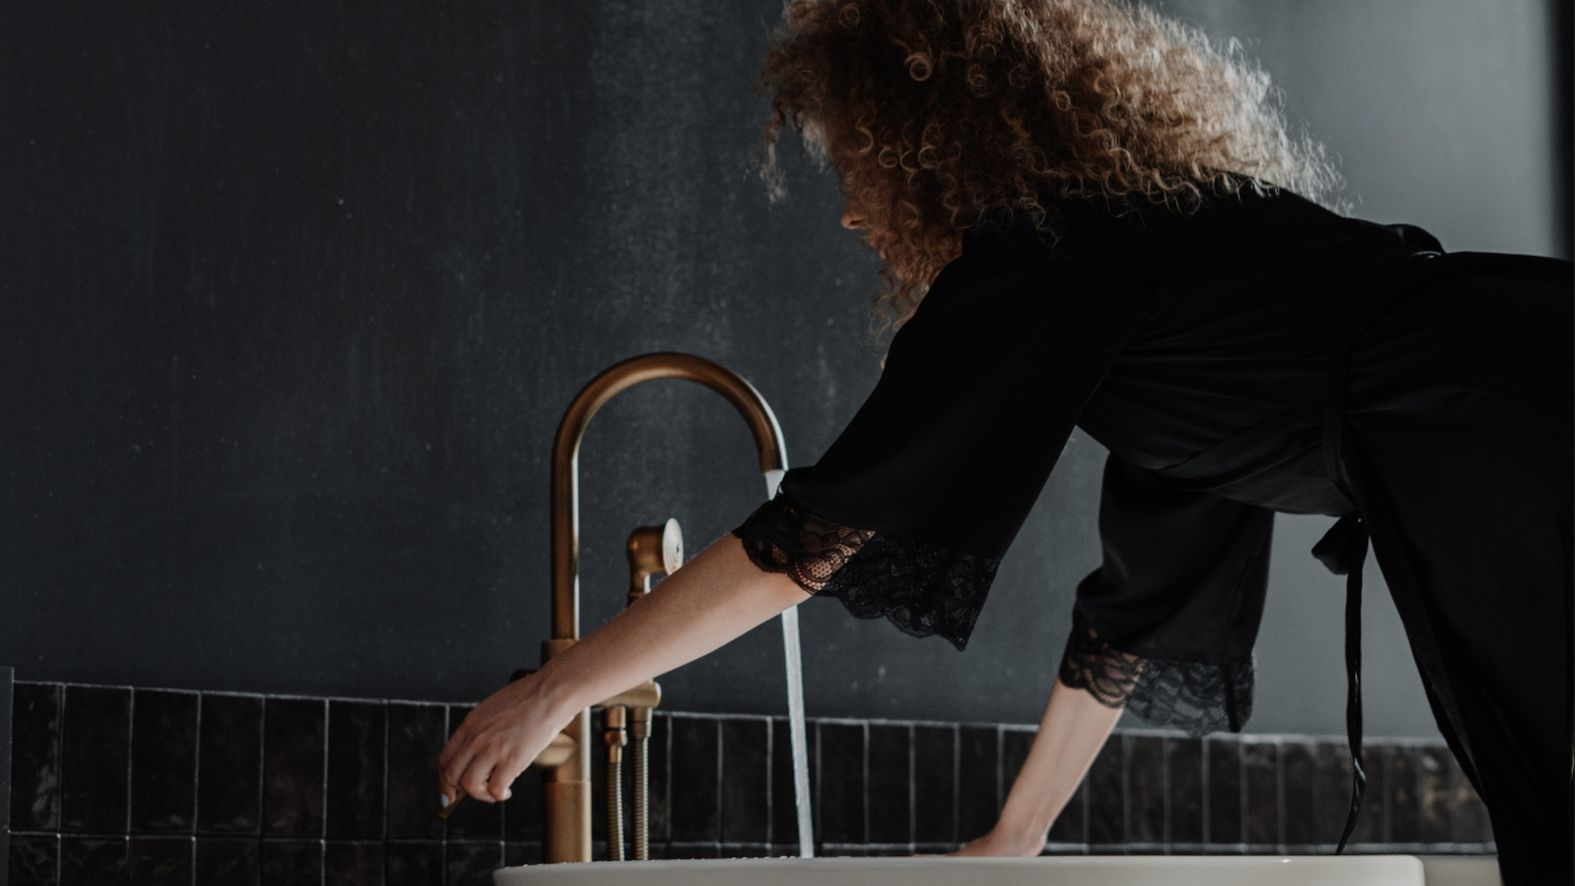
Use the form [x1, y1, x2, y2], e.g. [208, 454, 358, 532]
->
[493, 855, 1501, 886]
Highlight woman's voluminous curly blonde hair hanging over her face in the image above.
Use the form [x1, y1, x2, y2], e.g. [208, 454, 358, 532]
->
[751, 0, 1347, 344]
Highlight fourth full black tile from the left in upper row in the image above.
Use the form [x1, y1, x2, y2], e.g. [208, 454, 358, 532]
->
[197, 692, 263, 834]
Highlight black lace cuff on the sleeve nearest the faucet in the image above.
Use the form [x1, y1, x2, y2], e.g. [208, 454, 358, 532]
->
[732, 489, 1000, 652]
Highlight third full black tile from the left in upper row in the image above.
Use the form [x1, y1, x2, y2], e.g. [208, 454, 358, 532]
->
[131, 689, 198, 837]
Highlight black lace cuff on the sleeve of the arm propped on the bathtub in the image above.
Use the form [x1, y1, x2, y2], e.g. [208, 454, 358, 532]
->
[1060, 607, 1252, 735]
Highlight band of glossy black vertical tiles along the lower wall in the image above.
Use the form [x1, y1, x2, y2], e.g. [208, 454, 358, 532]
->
[9, 683, 1493, 886]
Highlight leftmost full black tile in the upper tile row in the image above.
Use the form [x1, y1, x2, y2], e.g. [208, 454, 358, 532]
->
[11, 683, 65, 831]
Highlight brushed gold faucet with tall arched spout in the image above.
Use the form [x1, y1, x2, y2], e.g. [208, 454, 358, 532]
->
[531, 351, 788, 864]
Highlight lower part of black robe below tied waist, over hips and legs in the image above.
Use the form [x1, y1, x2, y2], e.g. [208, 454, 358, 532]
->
[1343, 252, 1575, 886]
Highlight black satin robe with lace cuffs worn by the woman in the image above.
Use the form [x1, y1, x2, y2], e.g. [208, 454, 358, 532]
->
[732, 184, 1572, 886]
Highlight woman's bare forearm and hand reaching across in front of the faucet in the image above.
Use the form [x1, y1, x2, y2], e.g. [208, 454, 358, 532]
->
[438, 533, 810, 806]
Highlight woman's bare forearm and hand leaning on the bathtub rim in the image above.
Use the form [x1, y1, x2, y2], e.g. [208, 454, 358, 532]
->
[953, 677, 1121, 856]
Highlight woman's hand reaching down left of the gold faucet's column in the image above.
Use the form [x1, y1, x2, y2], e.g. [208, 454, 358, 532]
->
[438, 674, 573, 806]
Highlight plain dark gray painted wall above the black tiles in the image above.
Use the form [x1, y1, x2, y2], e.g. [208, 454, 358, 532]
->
[0, 0, 1569, 735]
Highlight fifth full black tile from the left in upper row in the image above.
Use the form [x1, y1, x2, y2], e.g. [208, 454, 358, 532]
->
[263, 697, 328, 837]
